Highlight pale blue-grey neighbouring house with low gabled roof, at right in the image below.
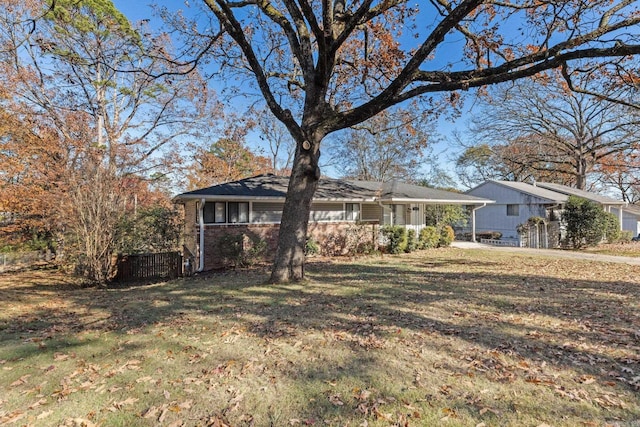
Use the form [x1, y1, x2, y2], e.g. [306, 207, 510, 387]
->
[467, 180, 640, 247]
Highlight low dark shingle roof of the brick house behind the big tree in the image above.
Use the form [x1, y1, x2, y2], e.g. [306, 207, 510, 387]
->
[175, 174, 492, 204]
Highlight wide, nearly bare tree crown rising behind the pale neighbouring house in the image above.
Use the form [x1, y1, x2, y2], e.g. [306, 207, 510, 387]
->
[458, 72, 640, 190]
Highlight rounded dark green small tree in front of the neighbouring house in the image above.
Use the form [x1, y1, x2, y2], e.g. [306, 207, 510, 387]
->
[562, 196, 607, 249]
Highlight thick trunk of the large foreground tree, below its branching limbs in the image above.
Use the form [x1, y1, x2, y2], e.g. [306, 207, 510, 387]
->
[270, 141, 320, 283]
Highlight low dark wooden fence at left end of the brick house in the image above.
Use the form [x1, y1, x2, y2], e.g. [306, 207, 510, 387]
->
[114, 252, 182, 282]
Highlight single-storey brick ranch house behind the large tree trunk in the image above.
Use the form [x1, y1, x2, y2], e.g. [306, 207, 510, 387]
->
[174, 174, 492, 271]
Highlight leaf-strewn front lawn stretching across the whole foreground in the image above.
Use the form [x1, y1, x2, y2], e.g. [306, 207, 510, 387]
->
[0, 249, 640, 426]
